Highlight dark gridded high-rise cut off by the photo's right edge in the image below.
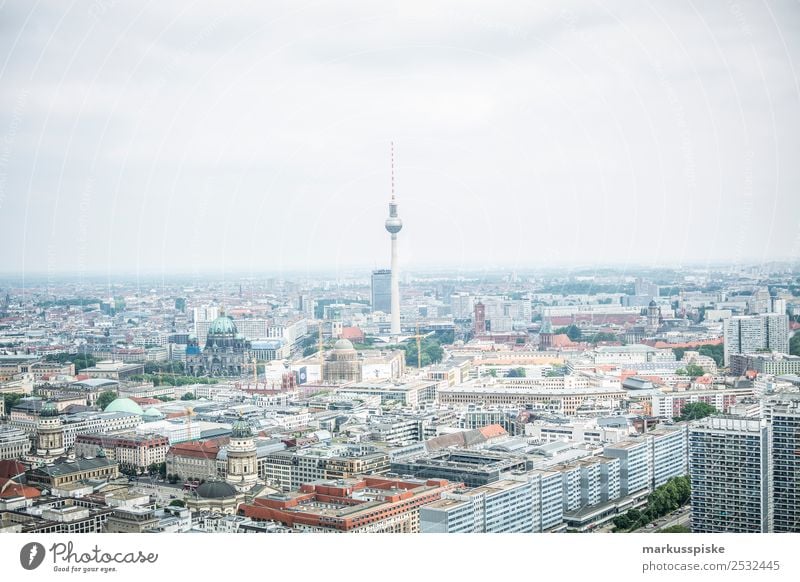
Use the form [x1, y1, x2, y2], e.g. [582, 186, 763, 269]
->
[772, 396, 800, 532]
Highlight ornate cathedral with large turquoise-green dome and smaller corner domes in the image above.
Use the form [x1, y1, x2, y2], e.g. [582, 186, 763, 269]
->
[186, 315, 250, 376]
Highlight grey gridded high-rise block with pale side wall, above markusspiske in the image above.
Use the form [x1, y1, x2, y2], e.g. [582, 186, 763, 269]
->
[689, 416, 772, 533]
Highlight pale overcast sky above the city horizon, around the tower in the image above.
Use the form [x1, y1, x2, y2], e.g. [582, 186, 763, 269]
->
[0, 0, 800, 274]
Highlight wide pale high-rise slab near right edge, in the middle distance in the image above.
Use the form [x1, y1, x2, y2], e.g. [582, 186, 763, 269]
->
[724, 313, 789, 366]
